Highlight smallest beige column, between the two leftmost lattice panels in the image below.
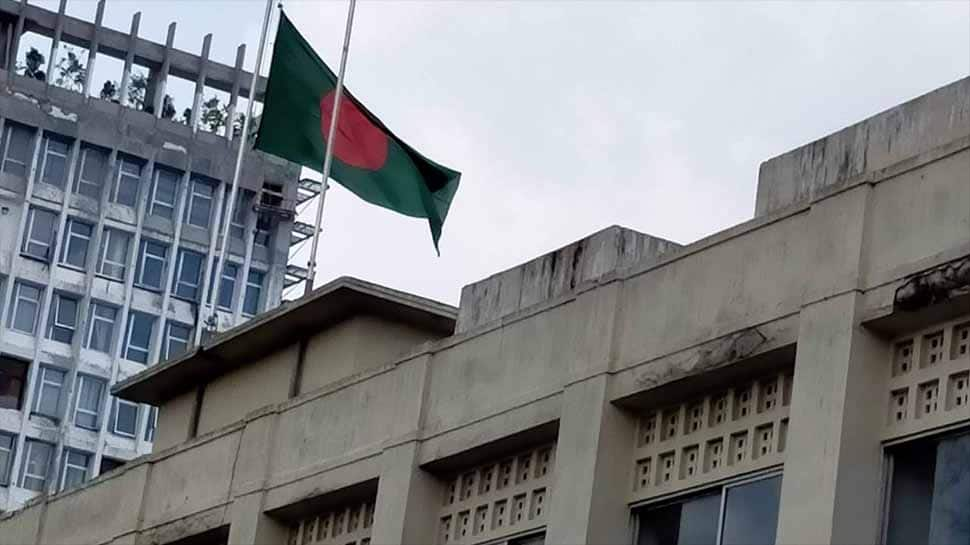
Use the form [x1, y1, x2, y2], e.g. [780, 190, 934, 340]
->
[371, 441, 442, 545]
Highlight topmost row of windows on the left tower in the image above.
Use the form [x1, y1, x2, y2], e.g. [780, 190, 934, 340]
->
[0, 123, 269, 240]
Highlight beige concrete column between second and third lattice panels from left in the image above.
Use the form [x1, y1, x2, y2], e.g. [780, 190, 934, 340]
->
[545, 374, 636, 545]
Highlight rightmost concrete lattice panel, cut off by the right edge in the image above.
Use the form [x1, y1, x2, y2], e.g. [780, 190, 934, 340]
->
[884, 316, 970, 440]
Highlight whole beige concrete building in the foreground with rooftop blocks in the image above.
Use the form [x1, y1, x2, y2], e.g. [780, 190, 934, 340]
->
[0, 72, 970, 545]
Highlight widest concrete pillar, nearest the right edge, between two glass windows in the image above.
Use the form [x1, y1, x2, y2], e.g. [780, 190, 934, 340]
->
[776, 291, 889, 544]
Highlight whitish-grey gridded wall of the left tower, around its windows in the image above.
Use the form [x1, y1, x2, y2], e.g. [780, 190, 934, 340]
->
[0, 0, 298, 510]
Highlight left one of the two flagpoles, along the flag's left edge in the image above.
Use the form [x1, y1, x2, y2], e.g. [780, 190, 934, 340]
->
[201, 0, 273, 344]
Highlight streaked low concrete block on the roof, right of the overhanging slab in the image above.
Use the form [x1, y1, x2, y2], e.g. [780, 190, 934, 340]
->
[455, 225, 680, 333]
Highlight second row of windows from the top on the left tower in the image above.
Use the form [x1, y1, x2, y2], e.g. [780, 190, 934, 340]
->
[20, 207, 265, 315]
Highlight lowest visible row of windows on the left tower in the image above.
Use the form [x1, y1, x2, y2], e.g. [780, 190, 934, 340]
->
[0, 424, 148, 492]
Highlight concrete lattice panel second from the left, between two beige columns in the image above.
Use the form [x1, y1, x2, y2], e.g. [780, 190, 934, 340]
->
[438, 444, 556, 545]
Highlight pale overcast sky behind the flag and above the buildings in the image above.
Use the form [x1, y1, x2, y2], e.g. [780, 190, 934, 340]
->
[31, 0, 970, 303]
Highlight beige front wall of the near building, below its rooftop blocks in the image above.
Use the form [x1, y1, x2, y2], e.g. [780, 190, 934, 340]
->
[0, 80, 970, 544]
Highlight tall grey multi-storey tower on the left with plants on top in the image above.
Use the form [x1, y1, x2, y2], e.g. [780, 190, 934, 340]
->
[0, 0, 313, 511]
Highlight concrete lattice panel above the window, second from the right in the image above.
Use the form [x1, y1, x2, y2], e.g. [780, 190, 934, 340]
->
[631, 371, 792, 501]
